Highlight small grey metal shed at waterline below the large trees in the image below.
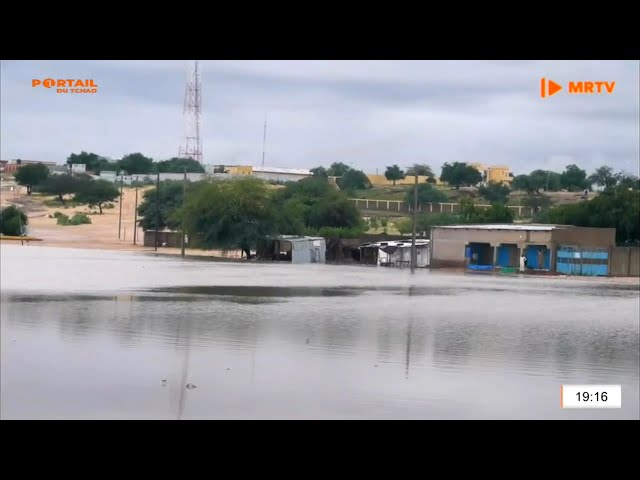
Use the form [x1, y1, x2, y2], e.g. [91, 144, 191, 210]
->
[256, 235, 327, 263]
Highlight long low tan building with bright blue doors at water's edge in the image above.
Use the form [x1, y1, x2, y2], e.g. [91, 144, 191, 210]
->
[431, 224, 616, 276]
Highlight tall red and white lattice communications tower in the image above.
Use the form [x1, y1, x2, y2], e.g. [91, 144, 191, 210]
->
[178, 60, 202, 163]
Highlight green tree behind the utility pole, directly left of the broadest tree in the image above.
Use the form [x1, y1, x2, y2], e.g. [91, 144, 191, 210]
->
[138, 180, 185, 231]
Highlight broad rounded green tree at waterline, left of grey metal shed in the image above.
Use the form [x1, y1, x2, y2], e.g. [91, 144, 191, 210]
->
[184, 177, 277, 252]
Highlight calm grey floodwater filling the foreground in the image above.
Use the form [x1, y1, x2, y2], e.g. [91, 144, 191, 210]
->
[0, 244, 640, 419]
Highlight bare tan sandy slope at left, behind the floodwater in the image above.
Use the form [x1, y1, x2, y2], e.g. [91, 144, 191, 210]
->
[0, 183, 240, 258]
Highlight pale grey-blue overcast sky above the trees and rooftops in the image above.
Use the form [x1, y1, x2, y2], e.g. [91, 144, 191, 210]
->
[0, 60, 640, 174]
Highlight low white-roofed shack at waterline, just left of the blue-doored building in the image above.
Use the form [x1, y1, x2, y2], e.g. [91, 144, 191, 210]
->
[359, 239, 431, 267]
